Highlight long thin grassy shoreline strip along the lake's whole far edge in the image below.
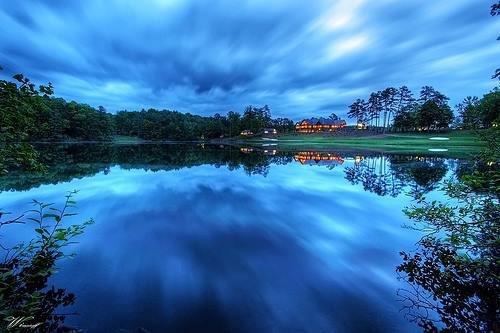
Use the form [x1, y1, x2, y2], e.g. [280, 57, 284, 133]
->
[7, 131, 484, 157]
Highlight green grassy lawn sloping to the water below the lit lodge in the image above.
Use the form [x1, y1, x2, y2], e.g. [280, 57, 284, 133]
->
[240, 131, 482, 155]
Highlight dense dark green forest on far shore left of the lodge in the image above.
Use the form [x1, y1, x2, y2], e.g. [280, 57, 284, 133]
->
[0, 69, 294, 143]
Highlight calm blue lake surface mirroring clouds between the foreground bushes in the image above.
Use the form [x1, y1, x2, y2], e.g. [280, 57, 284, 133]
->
[0, 145, 468, 332]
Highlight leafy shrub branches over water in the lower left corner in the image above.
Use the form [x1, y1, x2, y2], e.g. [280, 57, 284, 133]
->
[0, 192, 93, 332]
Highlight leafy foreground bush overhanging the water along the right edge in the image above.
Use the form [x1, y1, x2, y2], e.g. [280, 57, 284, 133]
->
[397, 128, 500, 332]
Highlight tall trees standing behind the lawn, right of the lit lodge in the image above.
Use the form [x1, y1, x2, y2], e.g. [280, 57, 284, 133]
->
[347, 86, 500, 133]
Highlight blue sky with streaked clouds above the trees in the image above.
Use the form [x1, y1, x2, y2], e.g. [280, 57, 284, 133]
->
[0, 0, 500, 120]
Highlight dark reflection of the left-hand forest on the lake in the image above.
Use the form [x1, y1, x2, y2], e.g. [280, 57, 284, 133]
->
[0, 144, 293, 191]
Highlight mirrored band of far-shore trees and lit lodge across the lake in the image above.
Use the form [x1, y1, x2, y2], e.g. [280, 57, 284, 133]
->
[0, 144, 467, 192]
